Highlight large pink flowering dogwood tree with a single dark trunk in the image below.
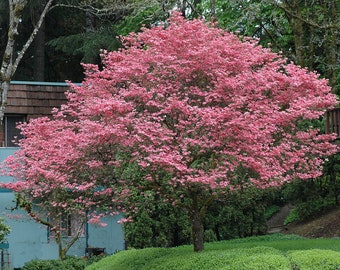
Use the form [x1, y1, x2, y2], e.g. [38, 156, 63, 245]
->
[0, 13, 337, 251]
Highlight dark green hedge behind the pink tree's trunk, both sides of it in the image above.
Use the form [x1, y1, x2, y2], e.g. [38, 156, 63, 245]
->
[124, 185, 281, 248]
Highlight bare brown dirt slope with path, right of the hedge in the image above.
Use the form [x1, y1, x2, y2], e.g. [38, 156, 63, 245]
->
[268, 205, 340, 238]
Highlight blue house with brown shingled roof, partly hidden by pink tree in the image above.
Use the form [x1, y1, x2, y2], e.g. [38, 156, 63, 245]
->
[0, 82, 125, 269]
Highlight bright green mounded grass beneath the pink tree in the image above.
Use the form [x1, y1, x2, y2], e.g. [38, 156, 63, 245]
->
[86, 234, 340, 270]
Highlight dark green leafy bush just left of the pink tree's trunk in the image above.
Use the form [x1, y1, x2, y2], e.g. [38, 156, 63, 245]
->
[115, 157, 191, 248]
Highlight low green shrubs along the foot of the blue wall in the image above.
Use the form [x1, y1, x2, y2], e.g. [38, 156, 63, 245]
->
[22, 256, 103, 270]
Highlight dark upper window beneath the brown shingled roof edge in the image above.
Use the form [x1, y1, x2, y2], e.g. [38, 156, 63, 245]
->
[4, 115, 26, 147]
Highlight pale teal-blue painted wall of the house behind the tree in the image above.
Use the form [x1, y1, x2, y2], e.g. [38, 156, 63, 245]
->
[0, 148, 125, 268]
